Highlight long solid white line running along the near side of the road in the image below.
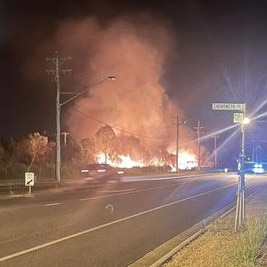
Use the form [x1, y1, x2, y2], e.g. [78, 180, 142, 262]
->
[0, 185, 232, 262]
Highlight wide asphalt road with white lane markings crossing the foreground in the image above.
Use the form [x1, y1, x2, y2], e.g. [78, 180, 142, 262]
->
[0, 173, 260, 267]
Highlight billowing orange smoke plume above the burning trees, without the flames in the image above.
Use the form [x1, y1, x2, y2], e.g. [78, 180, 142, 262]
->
[46, 14, 197, 154]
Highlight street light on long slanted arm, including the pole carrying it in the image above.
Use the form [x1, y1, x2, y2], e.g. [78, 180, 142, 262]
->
[56, 76, 116, 183]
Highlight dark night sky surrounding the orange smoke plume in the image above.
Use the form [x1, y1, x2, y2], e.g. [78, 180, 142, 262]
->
[0, 0, 267, 161]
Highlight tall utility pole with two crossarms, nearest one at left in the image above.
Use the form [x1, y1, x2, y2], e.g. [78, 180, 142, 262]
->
[46, 51, 71, 183]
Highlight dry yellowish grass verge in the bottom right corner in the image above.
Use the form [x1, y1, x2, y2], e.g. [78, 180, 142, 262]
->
[164, 214, 267, 267]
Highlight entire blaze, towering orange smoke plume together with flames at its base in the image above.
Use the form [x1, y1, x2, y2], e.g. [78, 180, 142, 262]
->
[26, 13, 211, 169]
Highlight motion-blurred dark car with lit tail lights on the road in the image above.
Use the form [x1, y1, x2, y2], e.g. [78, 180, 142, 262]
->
[81, 163, 124, 182]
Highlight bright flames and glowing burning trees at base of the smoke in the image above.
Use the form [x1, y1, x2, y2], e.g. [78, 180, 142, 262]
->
[81, 126, 197, 169]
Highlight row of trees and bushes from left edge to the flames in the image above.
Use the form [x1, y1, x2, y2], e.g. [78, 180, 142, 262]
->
[0, 125, 174, 182]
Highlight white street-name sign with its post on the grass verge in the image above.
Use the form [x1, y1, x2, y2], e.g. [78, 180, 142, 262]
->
[212, 103, 246, 231]
